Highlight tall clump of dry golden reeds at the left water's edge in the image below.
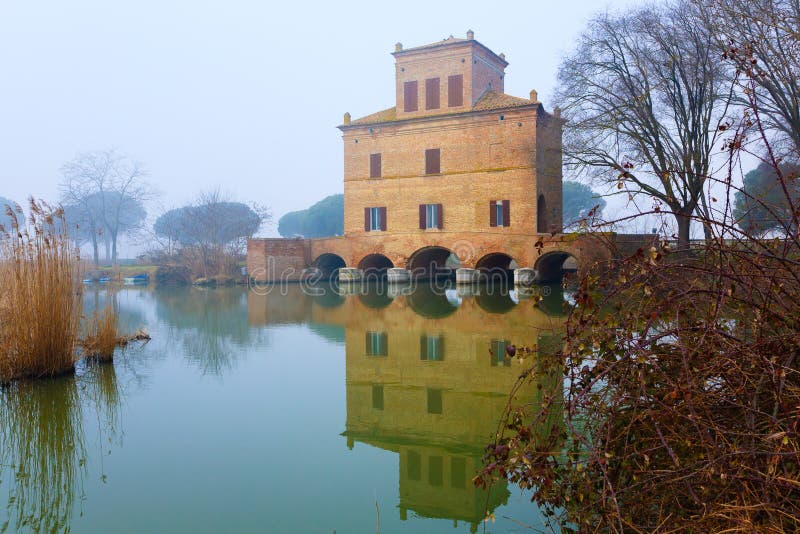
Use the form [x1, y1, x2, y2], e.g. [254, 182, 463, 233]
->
[0, 199, 81, 382]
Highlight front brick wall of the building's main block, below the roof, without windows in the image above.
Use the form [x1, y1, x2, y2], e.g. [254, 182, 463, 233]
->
[344, 106, 548, 235]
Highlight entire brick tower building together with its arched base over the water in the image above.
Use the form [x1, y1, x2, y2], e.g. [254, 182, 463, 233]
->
[248, 31, 616, 280]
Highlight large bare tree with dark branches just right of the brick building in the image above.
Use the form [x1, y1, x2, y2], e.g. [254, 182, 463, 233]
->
[557, 0, 731, 247]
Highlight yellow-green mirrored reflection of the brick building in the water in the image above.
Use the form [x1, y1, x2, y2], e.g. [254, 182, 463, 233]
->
[248, 285, 564, 531]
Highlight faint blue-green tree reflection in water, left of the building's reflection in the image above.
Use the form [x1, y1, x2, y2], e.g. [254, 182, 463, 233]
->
[156, 288, 262, 375]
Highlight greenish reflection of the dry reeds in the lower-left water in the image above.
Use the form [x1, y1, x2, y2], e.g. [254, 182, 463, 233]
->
[0, 364, 120, 532]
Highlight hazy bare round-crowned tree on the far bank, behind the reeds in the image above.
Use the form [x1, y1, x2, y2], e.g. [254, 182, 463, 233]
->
[61, 150, 154, 264]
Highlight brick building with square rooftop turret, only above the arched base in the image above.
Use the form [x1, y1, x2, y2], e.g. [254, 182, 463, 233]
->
[339, 32, 561, 245]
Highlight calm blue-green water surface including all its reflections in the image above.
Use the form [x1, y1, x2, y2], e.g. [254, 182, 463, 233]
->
[0, 285, 563, 533]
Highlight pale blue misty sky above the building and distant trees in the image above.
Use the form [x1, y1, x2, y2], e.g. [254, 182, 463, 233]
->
[0, 0, 640, 234]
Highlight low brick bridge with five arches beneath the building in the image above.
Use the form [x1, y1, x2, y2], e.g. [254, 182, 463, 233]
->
[247, 232, 653, 282]
